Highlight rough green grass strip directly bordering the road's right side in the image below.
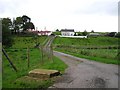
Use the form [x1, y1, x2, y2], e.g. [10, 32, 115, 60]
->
[55, 48, 120, 64]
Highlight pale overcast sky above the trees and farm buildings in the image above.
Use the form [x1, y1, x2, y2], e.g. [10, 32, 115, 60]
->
[0, 0, 119, 32]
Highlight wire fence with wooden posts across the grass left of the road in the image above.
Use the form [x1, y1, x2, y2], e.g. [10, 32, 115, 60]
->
[2, 36, 54, 72]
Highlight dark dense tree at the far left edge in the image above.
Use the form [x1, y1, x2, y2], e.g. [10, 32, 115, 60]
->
[2, 18, 13, 47]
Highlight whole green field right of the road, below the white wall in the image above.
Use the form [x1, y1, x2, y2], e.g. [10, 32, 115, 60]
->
[54, 37, 120, 64]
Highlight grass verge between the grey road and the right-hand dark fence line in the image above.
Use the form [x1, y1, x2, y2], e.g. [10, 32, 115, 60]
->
[55, 48, 120, 64]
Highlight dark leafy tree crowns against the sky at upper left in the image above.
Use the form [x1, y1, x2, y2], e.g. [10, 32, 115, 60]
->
[2, 15, 35, 34]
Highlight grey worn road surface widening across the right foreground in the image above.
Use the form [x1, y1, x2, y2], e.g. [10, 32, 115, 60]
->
[51, 51, 118, 88]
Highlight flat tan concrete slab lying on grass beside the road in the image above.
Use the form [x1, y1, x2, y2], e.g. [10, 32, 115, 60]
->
[28, 69, 60, 79]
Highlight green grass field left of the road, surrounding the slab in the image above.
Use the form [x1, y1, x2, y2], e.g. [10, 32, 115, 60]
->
[2, 36, 67, 88]
